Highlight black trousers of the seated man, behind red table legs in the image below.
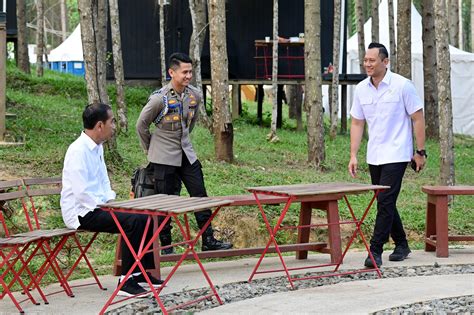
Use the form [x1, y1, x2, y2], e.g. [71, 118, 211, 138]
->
[79, 209, 155, 275]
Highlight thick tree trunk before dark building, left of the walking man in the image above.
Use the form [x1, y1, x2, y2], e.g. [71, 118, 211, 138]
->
[304, 0, 325, 169]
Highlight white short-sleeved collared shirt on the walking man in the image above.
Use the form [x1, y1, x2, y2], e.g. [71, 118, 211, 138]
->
[351, 69, 423, 165]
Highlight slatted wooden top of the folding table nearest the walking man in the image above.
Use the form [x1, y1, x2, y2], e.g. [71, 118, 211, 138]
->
[247, 183, 390, 196]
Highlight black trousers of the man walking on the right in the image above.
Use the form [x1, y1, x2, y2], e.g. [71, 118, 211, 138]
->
[369, 162, 408, 254]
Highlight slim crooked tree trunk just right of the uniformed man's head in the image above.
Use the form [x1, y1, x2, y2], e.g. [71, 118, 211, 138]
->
[189, 0, 213, 133]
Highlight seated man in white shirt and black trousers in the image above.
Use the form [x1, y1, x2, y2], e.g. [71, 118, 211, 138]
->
[61, 103, 163, 297]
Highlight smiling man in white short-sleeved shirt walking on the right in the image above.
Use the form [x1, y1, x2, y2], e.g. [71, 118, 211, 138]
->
[348, 43, 427, 268]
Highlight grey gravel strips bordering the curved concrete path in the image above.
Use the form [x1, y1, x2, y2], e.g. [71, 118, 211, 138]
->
[106, 263, 474, 315]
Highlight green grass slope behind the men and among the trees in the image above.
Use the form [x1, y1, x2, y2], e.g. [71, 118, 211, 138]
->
[0, 64, 474, 284]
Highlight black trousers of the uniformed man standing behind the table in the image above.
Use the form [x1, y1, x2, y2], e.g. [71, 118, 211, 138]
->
[153, 152, 213, 240]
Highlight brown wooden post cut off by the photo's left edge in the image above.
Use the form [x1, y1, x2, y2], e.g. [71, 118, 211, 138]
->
[0, 12, 7, 141]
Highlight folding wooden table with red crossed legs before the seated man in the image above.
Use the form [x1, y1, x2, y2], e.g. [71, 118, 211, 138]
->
[99, 194, 231, 314]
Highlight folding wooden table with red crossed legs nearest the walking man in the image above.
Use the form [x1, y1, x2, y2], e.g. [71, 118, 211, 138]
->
[247, 183, 390, 288]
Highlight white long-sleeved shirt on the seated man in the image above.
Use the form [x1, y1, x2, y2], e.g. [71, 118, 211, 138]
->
[61, 132, 115, 229]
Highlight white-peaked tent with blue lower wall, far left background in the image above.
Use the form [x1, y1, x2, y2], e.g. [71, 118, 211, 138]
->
[48, 24, 84, 75]
